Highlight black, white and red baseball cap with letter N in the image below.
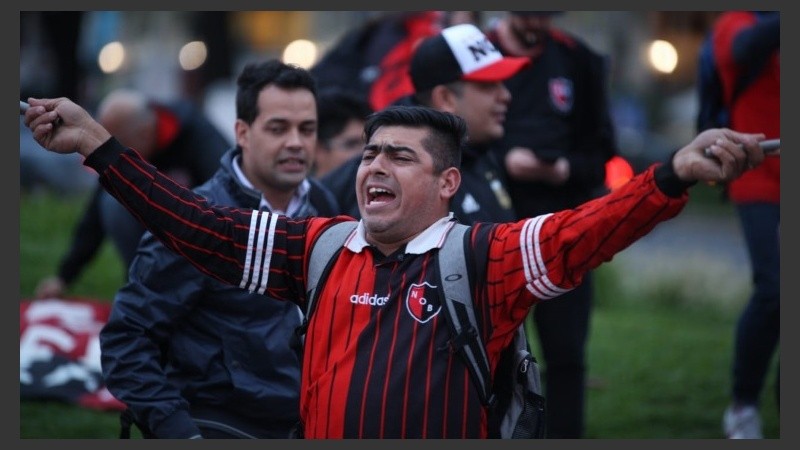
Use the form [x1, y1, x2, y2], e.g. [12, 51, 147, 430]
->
[409, 24, 530, 92]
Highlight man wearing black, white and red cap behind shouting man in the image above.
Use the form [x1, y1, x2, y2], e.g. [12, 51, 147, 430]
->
[321, 24, 528, 224]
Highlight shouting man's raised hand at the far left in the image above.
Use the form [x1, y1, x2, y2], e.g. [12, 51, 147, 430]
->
[25, 97, 111, 156]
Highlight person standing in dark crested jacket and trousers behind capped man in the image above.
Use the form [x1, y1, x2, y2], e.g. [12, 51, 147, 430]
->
[487, 11, 617, 438]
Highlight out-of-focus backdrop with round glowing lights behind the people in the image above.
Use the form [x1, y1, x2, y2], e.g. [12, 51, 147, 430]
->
[20, 11, 719, 194]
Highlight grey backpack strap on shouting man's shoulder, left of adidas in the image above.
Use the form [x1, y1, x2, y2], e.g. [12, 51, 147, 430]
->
[295, 221, 358, 338]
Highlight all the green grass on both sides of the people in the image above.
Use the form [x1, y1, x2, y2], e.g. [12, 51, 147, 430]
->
[20, 188, 780, 439]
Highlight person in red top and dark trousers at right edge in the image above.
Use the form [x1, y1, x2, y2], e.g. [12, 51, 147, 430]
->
[711, 11, 781, 439]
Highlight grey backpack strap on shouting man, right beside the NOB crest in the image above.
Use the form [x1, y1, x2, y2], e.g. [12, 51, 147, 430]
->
[437, 223, 496, 406]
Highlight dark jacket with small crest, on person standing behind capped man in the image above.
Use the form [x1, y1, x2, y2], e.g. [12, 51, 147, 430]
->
[487, 25, 618, 218]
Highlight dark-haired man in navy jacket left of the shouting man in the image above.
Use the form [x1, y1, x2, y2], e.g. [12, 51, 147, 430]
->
[100, 59, 339, 439]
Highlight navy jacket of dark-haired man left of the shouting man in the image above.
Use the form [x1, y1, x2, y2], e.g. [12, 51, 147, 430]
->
[100, 147, 338, 438]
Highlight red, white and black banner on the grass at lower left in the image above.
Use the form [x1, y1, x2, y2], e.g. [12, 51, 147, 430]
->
[19, 299, 125, 410]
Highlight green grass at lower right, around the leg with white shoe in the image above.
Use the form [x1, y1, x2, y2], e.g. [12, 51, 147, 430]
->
[587, 294, 780, 439]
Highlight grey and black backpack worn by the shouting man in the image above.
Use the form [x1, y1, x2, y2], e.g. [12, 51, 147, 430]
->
[298, 221, 545, 439]
